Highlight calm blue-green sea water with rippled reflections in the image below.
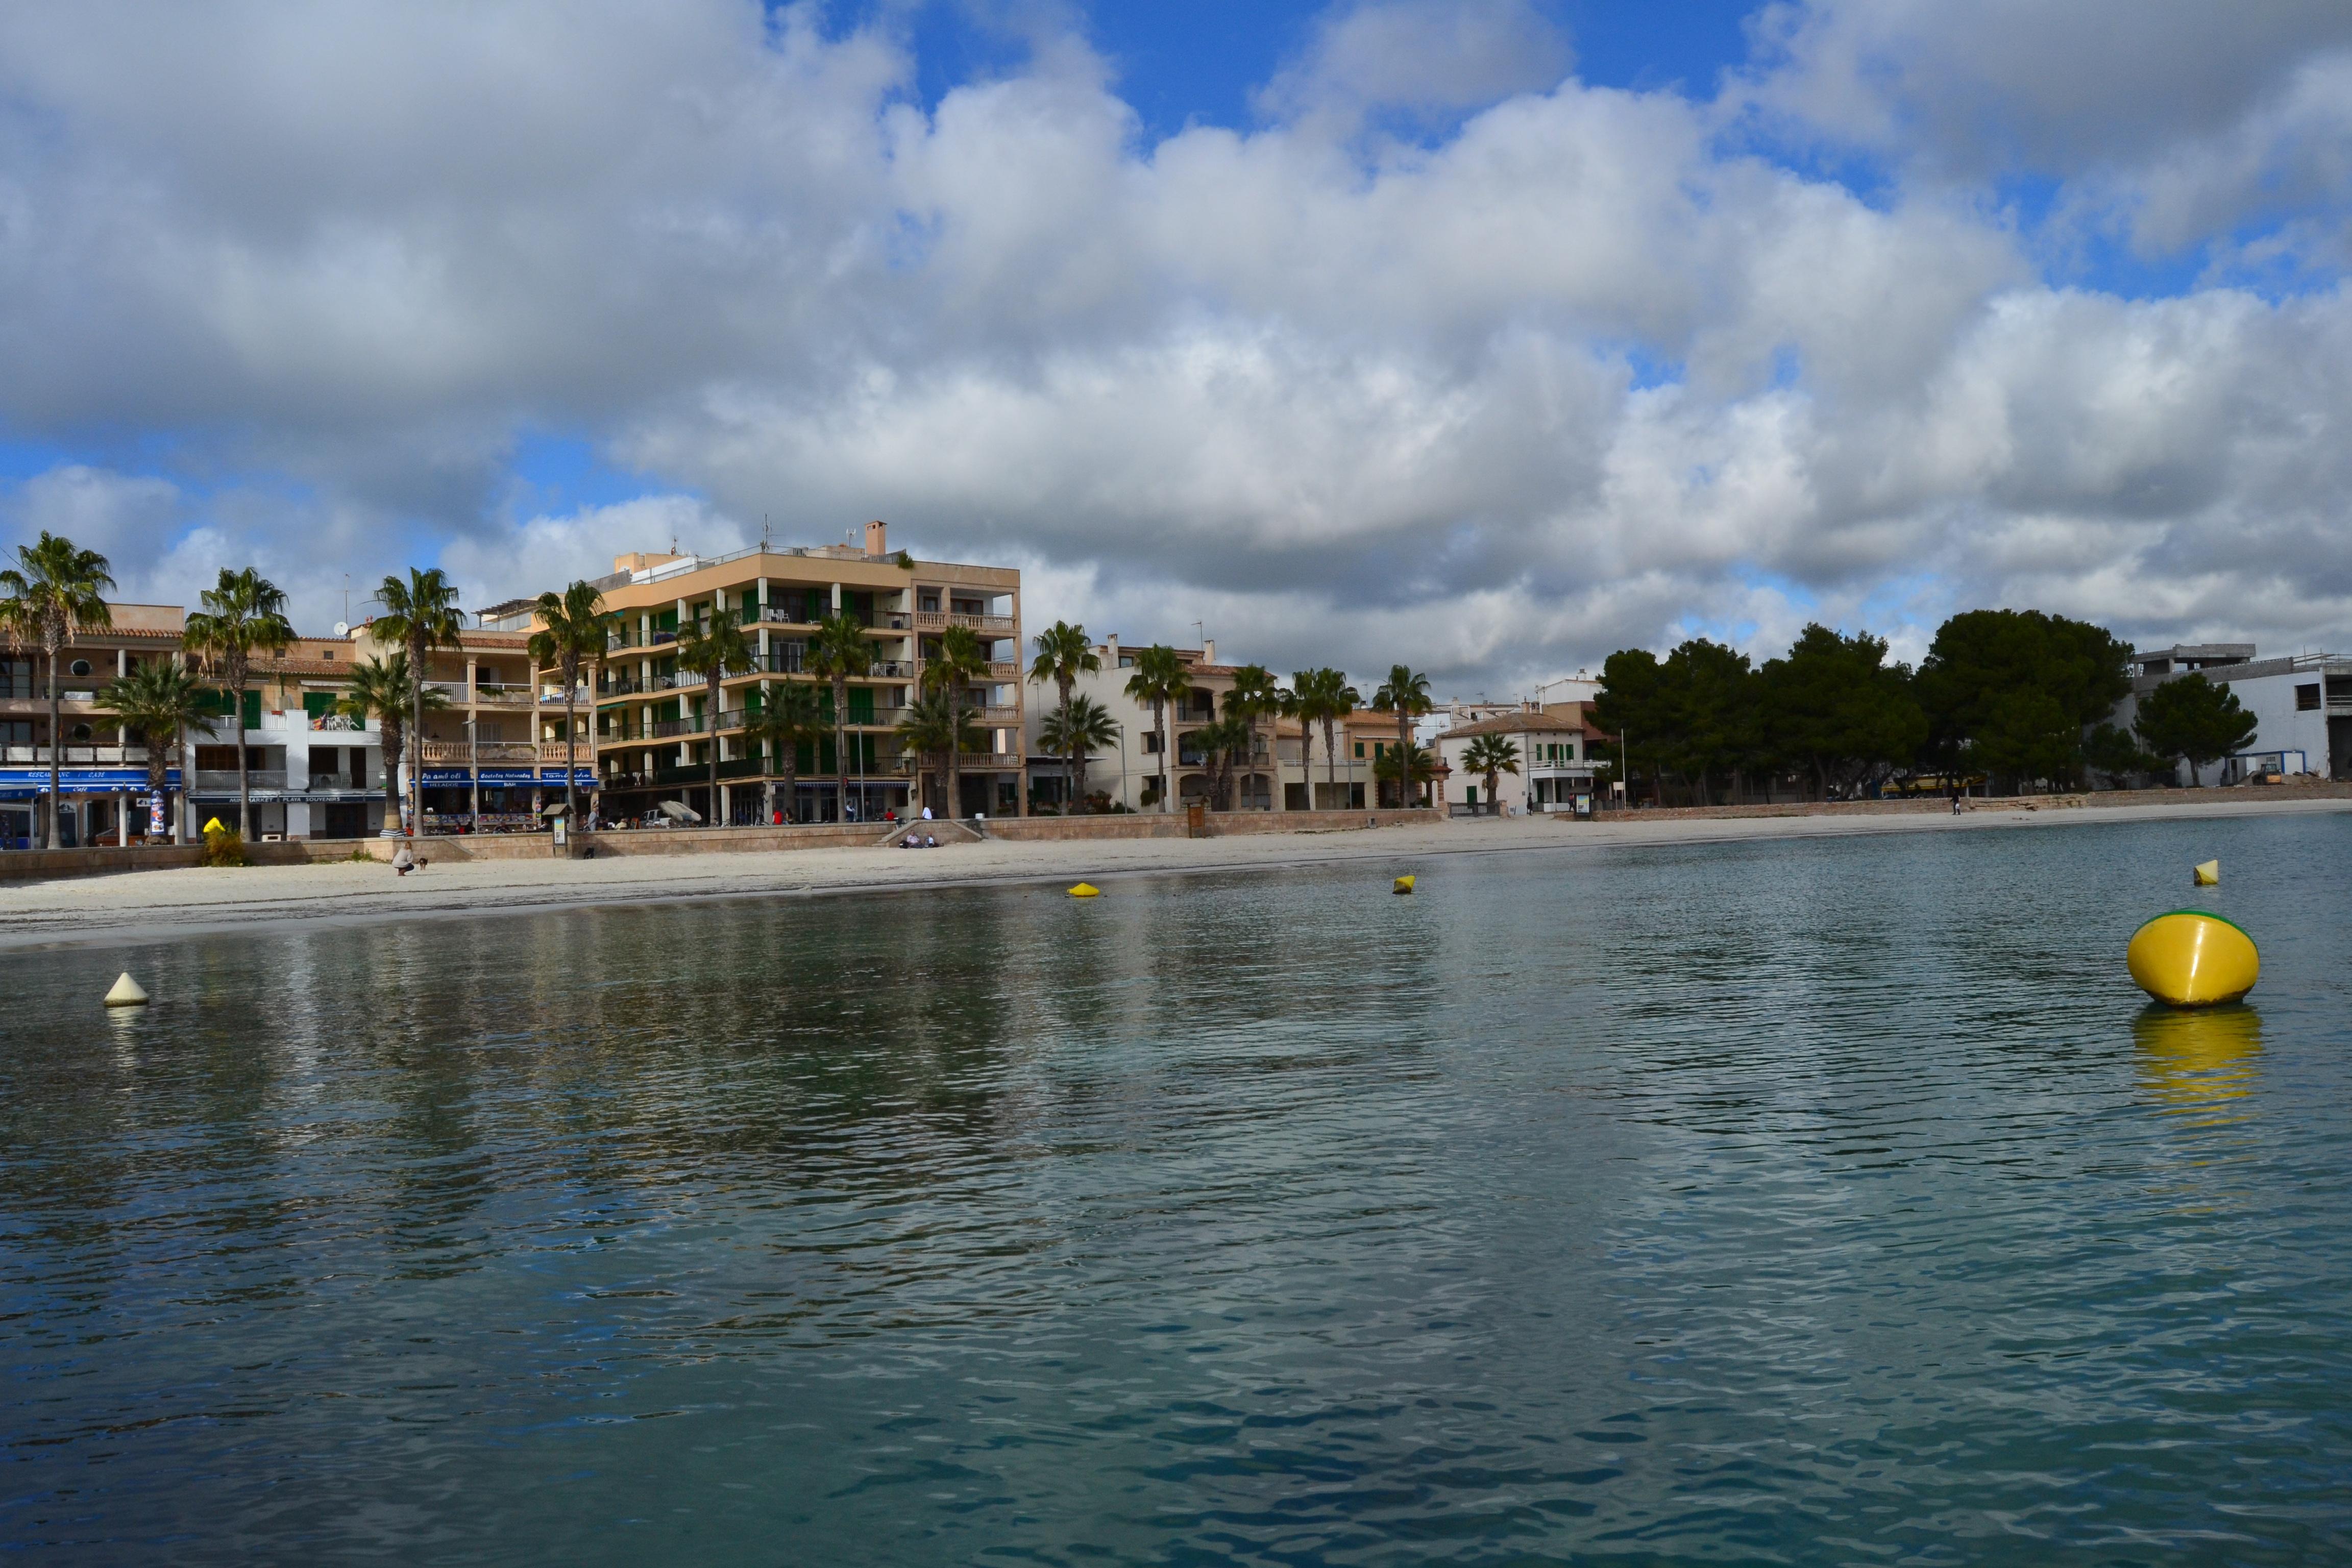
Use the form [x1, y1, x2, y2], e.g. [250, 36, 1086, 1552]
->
[0, 816, 2352, 1565]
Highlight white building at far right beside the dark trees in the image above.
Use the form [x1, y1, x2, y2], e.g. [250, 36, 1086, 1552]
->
[2112, 642, 2352, 783]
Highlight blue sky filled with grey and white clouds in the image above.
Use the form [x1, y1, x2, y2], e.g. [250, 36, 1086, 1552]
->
[0, 0, 2352, 691]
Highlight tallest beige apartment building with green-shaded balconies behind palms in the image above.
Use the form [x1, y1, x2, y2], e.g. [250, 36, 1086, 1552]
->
[569, 522, 1025, 823]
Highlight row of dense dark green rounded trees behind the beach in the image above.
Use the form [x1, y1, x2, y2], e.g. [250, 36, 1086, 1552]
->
[1595, 609, 2256, 804]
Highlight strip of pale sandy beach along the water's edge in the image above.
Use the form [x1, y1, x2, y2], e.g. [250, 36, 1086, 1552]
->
[0, 795, 2352, 952]
